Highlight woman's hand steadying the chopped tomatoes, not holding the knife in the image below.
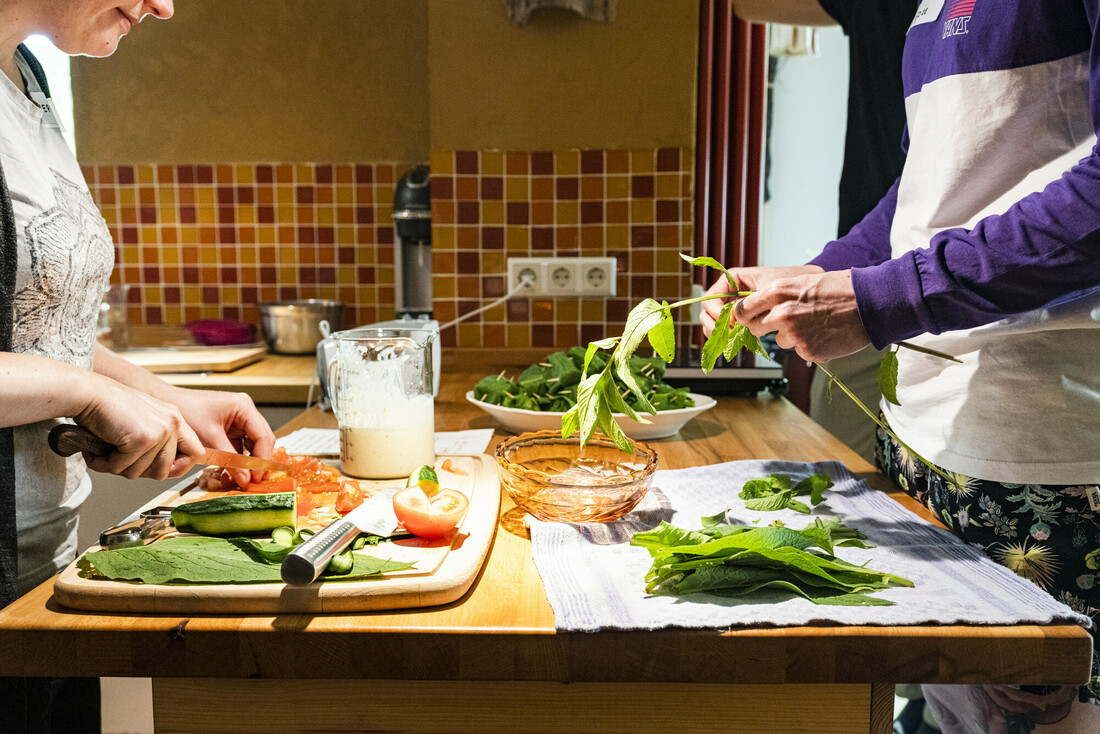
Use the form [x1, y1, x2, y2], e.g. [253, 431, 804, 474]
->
[161, 387, 275, 486]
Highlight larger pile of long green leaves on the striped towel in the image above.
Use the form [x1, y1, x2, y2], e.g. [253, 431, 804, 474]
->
[630, 516, 913, 606]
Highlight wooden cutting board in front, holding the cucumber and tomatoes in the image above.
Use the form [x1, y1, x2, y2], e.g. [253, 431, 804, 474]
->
[54, 454, 501, 614]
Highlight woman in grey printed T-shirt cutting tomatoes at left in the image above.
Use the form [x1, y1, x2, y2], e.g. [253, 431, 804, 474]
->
[0, 0, 275, 732]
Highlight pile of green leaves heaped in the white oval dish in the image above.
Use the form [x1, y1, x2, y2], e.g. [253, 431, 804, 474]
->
[474, 347, 695, 413]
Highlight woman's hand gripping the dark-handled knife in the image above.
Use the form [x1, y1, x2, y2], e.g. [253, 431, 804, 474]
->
[74, 375, 202, 479]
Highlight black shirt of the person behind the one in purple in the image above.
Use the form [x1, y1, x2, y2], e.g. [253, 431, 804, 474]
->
[818, 0, 919, 237]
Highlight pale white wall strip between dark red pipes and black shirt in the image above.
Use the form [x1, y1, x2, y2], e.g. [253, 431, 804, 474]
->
[760, 26, 848, 265]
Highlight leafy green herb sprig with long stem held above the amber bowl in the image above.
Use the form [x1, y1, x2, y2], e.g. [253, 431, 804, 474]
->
[561, 254, 959, 483]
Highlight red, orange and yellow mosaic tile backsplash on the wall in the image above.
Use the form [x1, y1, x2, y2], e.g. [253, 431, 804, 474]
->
[85, 149, 693, 348]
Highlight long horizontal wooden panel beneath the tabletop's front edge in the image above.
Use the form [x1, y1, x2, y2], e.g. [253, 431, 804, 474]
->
[153, 678, 893, 734]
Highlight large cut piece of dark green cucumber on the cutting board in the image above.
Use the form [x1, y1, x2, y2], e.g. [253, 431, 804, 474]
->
[172, 492, 296, 536]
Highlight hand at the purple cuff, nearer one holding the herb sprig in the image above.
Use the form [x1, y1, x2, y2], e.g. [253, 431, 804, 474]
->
[734, 271, 870, 362]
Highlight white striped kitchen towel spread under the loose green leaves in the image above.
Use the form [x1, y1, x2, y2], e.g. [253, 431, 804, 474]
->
[528, 461, 1089, 632]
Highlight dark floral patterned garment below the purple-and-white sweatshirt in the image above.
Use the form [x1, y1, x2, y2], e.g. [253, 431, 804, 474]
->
[875, 428, 1100, 732]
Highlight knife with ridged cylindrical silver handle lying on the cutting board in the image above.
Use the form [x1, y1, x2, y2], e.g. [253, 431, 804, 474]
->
[279, 487, 400, 587]
